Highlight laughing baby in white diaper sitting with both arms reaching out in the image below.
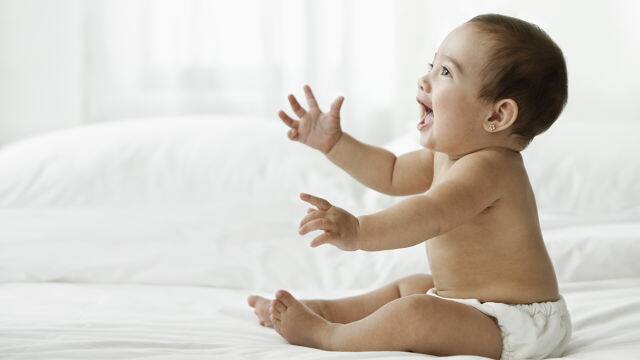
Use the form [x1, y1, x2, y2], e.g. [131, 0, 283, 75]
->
[247, 14, 571, 359]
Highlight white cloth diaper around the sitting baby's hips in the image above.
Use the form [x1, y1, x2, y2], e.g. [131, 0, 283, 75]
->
[427, 288, 571, 359]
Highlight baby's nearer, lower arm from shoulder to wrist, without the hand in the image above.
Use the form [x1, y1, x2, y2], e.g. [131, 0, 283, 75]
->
[358, 153, 501, 251]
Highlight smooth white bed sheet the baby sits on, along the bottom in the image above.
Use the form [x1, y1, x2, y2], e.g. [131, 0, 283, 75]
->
[0, 278, 640, 359]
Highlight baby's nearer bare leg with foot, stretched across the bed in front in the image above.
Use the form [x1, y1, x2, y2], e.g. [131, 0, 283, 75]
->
[271, 290, 502, 359]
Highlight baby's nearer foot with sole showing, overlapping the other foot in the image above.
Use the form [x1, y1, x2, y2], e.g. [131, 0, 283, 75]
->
[270, 290, 332, 349]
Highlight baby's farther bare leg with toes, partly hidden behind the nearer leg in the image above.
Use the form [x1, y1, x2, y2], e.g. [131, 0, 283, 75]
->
[247, 274, 433, 327]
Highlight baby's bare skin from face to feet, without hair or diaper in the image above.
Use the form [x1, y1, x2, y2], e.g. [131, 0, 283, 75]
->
[248, 24, 559, 358]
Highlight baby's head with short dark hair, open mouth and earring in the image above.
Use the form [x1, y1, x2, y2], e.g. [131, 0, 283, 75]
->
[417, 14, 567, 158]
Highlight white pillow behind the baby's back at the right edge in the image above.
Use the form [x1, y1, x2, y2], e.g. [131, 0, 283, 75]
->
[523, 120, 640, 218]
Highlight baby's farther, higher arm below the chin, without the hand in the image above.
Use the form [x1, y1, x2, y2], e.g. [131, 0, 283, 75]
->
[326, 133, 433, 196]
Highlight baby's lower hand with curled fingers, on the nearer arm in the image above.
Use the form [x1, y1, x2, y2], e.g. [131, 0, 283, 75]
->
[298, 193, 360, 251]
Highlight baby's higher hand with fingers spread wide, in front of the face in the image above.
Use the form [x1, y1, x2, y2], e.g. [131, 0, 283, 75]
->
[278, 85, 344, 154]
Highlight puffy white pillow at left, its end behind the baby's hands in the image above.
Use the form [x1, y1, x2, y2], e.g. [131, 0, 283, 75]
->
[0, 117, 356, 207]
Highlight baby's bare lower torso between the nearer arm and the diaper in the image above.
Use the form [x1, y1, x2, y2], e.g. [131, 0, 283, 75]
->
[426, 234, 559, 304]
